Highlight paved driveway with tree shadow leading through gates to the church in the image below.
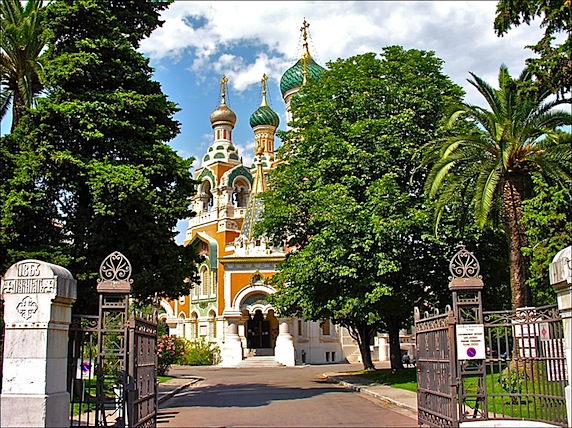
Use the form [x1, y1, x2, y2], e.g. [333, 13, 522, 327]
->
[158, 364, 418, 427]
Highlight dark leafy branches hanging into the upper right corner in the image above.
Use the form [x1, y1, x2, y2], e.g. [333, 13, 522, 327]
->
[494, 0, 572, 96]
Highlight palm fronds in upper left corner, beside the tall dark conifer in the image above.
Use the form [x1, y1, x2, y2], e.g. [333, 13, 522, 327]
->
[0, 0, 45, 130]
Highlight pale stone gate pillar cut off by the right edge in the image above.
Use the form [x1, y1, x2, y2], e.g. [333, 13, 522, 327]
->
[550, 246, 572, 426]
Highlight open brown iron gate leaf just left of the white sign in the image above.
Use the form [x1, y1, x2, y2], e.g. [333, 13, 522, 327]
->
[415, 308, 458, 427]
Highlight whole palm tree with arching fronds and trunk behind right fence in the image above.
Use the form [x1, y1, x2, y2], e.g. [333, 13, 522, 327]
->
[425, 65, 572, 308]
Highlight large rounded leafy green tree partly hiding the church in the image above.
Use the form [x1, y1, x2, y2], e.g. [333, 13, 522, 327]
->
[259, 46, 463, 369]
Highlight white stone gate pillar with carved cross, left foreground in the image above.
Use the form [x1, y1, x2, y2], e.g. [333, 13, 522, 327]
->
[0, 260, 77, 427]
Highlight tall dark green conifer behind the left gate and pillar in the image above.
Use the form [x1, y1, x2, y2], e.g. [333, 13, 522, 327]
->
[0, 0, 197, 311]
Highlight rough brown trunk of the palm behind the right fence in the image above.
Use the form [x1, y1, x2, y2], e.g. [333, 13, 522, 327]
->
[502, 172, 532, 309]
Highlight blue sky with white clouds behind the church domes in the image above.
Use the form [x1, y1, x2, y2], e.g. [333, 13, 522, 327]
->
[2, 0, 543, 242]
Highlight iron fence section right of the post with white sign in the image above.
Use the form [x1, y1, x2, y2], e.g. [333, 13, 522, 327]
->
[484, 305, 570, 427]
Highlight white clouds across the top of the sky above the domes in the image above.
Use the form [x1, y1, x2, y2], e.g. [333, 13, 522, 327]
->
[141, 1, 542, 104]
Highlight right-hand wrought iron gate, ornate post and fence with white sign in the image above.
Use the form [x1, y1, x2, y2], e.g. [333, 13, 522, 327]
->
[415, 247, 570, 427]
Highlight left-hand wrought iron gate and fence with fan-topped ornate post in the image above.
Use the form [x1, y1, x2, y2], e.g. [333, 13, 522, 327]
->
[68, 252, 158, 427]
